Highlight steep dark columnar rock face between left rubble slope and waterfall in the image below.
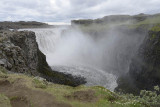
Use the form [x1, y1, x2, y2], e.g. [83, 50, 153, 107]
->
[10, 31, 40, 74]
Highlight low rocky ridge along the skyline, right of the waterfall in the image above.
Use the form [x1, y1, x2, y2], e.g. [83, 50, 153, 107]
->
[71, 13, 160, 25]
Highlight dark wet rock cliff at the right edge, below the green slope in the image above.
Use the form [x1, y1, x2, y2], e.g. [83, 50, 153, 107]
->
[116, 26, 160, 94]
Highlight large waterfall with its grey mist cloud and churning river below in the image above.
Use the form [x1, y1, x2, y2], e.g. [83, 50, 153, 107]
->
[24, 27, 146, 91]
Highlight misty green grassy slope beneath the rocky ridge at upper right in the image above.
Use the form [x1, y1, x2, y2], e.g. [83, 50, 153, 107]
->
[78, 15, 160, 33]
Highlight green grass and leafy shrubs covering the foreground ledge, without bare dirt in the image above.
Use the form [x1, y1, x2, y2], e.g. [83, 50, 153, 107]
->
[0, 67, 160, 107]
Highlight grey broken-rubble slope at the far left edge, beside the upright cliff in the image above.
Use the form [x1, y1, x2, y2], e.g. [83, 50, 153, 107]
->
[0, 31, 29, 73]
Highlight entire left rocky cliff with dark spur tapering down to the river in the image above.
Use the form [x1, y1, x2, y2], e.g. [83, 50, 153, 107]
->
[0, 31, 85, 86]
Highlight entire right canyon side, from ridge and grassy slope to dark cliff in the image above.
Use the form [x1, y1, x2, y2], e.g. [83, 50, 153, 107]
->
[72, 14, 160, 94]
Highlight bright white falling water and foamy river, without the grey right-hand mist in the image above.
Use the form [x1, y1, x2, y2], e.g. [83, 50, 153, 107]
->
[23, 27, 117, 91]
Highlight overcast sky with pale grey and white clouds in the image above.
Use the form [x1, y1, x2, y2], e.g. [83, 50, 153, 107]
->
[0, 0, 160, 23]
